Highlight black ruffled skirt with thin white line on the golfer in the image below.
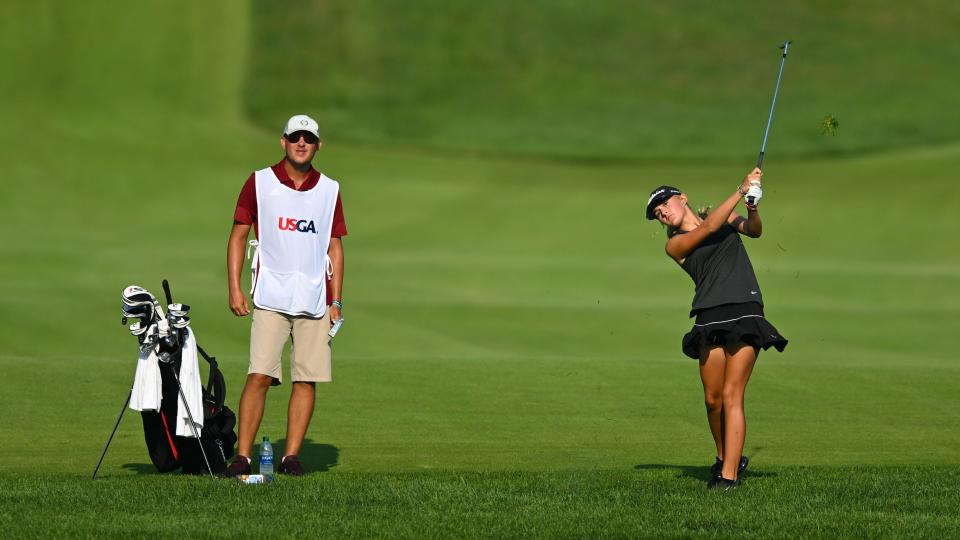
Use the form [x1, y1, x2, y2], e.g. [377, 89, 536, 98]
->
[683, 302, 787, 360]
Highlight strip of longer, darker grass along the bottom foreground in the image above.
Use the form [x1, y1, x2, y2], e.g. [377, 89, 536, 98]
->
[0, 465, 960, 538]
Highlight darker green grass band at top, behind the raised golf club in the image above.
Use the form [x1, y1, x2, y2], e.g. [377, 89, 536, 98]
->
[244, 0, 960, 163]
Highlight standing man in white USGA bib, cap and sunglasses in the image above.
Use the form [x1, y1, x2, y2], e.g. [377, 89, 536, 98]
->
[224, 115, 347, 476]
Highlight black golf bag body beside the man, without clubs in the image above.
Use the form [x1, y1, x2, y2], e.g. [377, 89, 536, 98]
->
[140, 341, 237, 474]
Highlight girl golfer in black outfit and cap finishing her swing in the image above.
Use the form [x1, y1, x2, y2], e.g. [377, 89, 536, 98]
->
[647, 168, 787, 490]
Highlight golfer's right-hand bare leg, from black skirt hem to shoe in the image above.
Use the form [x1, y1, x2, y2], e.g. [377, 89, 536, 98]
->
[721, 344, 757, 480]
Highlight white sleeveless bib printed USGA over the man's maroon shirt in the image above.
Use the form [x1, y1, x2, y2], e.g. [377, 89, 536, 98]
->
[253, 167, 340, 317]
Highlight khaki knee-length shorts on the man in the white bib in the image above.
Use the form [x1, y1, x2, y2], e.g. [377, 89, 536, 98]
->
[247, 308, 333, 385]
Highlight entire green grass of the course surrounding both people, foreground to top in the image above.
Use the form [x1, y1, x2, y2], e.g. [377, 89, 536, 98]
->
[0, 1, 960, 538]
